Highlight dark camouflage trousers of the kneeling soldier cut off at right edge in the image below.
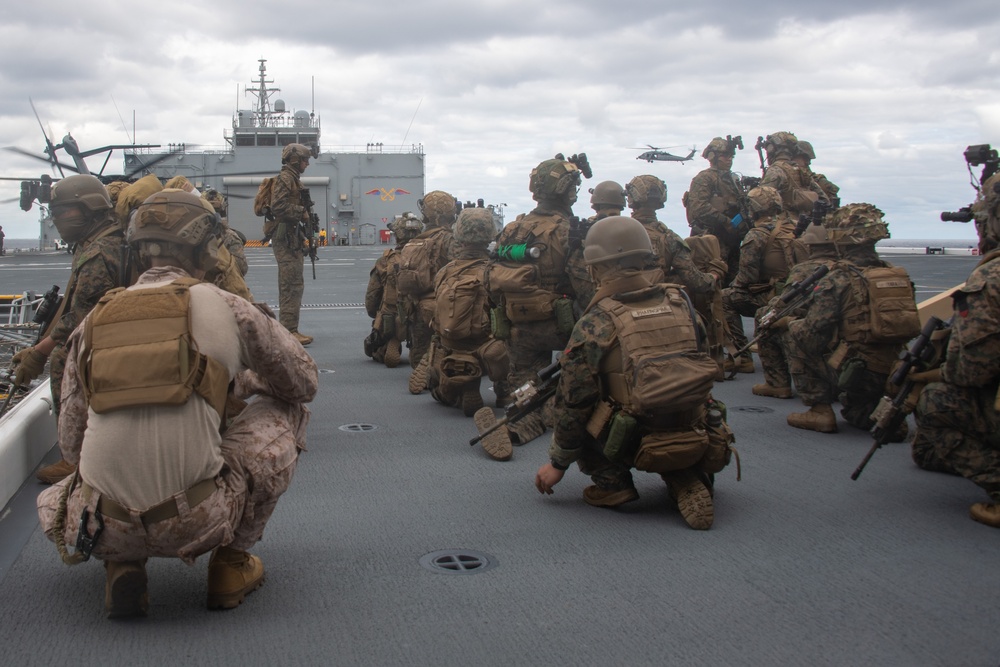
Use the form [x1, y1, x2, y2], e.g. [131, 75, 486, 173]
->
[913, 382, 1000, 501]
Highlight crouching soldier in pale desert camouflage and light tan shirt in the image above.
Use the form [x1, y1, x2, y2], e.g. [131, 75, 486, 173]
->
[38, 189, 318, 618]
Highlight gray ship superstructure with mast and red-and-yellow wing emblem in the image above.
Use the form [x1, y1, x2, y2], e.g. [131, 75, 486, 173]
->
[125, 59, 424, 245]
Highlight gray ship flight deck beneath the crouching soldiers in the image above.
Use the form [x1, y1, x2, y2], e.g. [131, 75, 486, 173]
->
[0, 246, 1000, 666]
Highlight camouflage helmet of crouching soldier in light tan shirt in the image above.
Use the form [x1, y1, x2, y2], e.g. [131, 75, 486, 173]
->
[125, 188, 222, 271]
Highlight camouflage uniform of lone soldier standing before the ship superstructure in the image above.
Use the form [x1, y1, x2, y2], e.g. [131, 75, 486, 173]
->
[271, 164, 307, 333]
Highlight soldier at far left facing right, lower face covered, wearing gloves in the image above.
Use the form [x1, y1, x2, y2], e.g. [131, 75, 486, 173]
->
[13, 174, 134, 484]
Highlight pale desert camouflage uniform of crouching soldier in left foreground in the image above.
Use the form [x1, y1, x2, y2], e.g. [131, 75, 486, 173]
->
[38, 267, 318, 563]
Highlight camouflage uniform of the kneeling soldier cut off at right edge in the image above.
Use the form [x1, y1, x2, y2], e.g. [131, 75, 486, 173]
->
[913, 252, 1000, 502]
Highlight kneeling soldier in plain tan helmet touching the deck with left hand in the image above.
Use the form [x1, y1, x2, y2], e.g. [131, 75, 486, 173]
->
[535, 217, 733, 530]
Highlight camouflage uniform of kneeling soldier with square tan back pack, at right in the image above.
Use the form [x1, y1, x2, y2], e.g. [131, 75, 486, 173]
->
[786, 245, 903, 430]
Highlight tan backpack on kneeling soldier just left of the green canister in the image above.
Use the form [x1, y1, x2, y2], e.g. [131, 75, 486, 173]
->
[434, 260, 490, 341]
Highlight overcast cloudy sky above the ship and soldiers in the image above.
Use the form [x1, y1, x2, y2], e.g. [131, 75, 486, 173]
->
[0, 0, 1000, 239]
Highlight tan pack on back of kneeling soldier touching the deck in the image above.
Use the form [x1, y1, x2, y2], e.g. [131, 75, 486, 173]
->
[601, 285, 718, 422]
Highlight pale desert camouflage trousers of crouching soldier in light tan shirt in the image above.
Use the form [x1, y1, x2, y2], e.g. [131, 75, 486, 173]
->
[38, 396, 309, 564]
